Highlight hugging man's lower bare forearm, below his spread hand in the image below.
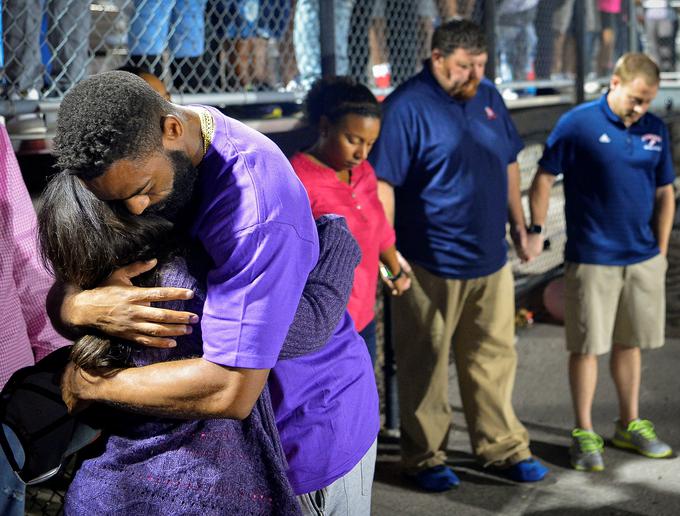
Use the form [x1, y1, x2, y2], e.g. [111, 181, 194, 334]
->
[62, 358, 269, 419]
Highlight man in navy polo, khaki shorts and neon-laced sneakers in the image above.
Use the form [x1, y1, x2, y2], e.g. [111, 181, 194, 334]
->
[529, 53, 675, 471]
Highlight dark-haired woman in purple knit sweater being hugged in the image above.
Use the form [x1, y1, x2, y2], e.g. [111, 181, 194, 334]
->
[39, 173, 359, 516]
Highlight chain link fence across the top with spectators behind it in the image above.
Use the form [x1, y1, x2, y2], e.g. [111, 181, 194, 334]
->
[0, 0, 679, 110]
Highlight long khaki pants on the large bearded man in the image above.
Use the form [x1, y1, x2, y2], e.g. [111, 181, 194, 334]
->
[392, 265, 531, 472]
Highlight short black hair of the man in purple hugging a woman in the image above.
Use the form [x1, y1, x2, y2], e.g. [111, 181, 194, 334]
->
[54, 71, 172, 179]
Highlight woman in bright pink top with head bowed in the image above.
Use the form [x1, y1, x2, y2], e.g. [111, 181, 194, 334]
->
[291, 77, 411, 363]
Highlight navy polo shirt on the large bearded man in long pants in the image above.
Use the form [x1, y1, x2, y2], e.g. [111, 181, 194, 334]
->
[369, 71, 523, 279]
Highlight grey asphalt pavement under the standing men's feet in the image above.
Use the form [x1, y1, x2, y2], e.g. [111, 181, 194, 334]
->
[373, 324, 680, 516]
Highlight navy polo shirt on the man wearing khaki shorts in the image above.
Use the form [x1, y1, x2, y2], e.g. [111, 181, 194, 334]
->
[539, 95, 675, 265]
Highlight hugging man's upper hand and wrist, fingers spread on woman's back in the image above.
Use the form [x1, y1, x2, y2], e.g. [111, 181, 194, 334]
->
[48, 260, 198, 348]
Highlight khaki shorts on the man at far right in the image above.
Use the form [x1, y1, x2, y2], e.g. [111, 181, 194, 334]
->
[564, 254, 668, 355]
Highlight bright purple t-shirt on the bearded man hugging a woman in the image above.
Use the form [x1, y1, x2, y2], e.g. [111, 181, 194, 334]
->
[192, 109, 380, 494]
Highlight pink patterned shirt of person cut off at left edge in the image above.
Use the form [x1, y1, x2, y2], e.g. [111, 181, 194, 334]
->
[0, 124, 69, 387]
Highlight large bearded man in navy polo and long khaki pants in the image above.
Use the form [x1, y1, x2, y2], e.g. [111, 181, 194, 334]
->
[369, 20, 547, 491]
